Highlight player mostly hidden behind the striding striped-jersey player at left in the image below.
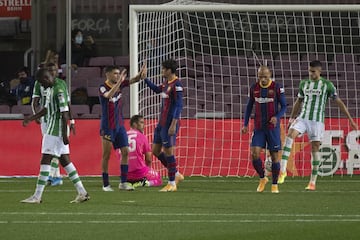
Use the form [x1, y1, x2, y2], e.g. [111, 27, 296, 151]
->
[31, 62, 75, 186]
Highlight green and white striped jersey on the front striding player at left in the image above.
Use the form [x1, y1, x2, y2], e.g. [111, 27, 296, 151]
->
[45, 78, 69, 137]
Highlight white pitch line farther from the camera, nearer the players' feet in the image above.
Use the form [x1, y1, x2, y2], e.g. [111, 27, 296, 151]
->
[0, 212, 360, 218]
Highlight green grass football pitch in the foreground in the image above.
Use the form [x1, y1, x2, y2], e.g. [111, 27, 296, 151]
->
[0, 176, 360, 240]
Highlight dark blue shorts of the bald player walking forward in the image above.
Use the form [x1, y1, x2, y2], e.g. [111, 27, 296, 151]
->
[251, 128, 281, 152]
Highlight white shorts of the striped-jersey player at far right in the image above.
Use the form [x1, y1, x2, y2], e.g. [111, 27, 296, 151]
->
[290, 118, 325, 142]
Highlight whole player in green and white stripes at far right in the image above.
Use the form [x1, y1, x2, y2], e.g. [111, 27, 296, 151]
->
[279, 60, 358, 191]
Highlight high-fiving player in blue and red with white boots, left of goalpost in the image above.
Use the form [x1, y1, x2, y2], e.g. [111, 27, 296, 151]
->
[99, 66, 145, 192]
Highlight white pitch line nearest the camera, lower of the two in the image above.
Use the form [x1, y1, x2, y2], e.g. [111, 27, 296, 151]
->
[0, 218, 360, 224]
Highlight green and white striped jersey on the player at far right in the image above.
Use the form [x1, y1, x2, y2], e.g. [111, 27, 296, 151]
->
[298, 77, 337, 122]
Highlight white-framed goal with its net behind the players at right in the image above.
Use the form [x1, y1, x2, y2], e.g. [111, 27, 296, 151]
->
[130, 1, 360, 176]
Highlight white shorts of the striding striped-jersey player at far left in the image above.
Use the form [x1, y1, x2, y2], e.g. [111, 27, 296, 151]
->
[41, 134, 70, 157]
